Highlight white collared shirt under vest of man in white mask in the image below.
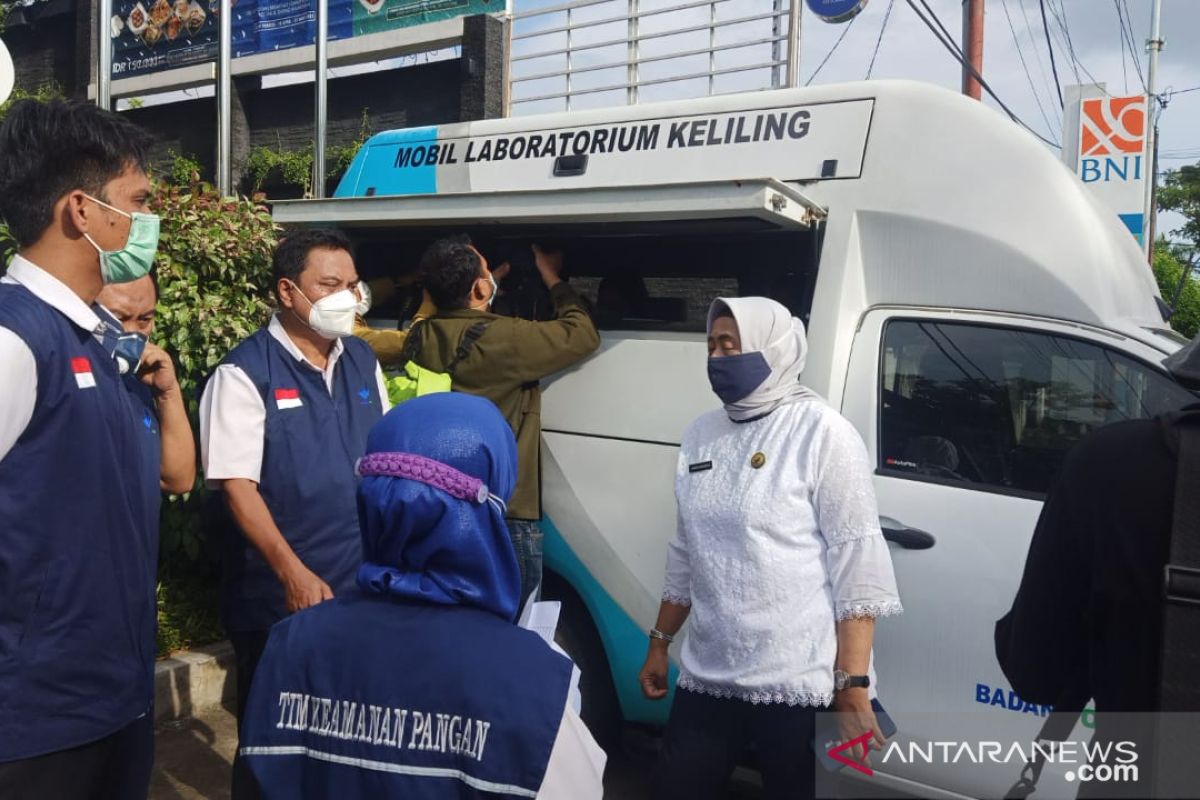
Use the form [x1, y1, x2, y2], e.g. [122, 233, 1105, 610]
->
[200, 315, 391, 488]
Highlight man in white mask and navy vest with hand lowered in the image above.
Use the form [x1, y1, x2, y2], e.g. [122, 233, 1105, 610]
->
[200, 230, 389, 798]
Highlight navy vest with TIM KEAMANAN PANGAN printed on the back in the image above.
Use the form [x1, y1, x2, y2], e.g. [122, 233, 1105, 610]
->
[241, 594, 571, 800]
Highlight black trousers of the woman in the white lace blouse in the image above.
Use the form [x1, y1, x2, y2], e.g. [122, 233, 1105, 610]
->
[654, 688, 817, 800]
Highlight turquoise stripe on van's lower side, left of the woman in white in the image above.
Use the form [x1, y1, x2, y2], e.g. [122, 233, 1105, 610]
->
[541, 518, 678, 726]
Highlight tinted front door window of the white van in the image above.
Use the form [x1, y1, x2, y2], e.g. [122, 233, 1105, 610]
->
[878, 320, 1196, 495]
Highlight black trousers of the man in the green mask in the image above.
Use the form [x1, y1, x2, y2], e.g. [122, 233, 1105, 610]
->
[0, 711, 154, 800]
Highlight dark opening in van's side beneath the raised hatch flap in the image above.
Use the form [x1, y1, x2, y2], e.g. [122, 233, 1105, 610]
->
[355, 226, 818, 332]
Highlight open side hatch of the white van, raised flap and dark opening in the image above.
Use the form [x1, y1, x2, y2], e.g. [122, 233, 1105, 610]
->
[274, 179, 826, 331]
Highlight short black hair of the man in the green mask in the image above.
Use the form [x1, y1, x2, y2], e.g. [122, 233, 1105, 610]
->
[0, 100, 154, 247]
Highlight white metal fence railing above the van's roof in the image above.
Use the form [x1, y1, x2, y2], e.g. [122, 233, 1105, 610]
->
[508, 0, 800, 114]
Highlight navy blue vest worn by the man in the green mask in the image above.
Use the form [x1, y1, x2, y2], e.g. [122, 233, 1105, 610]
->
[0, 284, 158, 762]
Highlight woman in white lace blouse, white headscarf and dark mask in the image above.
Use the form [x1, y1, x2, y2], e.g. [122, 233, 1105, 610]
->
[640, 297, 901, 800]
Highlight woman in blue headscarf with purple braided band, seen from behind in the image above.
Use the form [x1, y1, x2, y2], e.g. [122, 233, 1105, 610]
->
[240, 393, 605, 799]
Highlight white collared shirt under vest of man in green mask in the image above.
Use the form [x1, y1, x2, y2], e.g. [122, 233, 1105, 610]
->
[0, 255, 111, 459]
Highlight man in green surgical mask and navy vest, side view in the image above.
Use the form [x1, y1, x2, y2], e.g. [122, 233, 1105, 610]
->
[0, 101, 166, 800]
